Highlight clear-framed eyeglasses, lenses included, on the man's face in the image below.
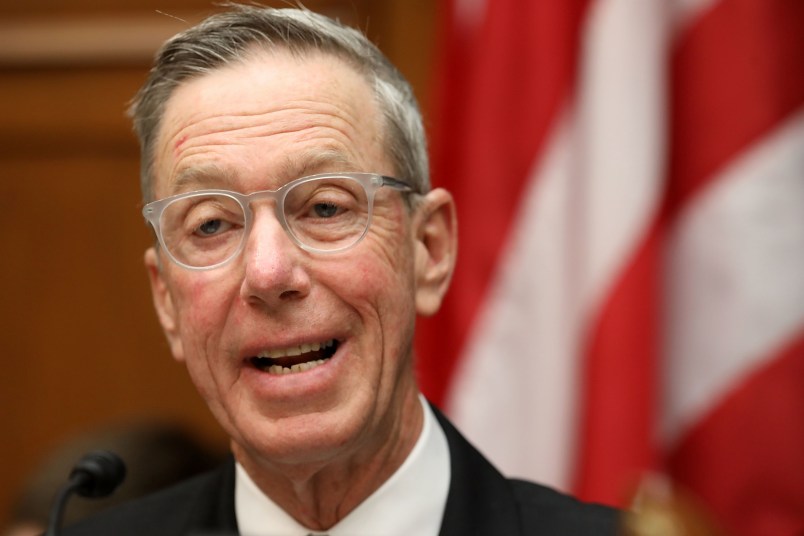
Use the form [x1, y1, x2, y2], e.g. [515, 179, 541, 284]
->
[142, 173, 413, 270]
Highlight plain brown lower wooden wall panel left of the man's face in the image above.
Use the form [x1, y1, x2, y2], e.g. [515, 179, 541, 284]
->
[0, 154, 229, 520]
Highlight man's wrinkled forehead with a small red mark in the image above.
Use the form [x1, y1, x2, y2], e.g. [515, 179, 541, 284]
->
[155, 51, 389, 194]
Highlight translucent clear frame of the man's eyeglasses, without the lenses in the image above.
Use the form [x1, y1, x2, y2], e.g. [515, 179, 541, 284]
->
[142, 172, 415, 271]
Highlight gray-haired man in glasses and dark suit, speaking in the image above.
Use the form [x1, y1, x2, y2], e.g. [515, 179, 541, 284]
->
[68, 6, 616, 536]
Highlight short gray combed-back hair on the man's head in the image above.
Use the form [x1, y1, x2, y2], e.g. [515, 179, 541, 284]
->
[129, 4, 430, 202]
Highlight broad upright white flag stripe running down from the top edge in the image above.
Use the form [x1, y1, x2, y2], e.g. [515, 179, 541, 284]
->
[573, 0, 667, 313]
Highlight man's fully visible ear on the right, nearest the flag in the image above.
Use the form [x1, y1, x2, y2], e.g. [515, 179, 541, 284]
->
[414, 188, 458, 316]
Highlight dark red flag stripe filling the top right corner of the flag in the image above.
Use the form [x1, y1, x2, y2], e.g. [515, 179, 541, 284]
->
[670, 0, 804, 211]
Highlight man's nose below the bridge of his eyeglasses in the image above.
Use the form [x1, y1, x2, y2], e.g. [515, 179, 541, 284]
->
[241, 210, 310, 306]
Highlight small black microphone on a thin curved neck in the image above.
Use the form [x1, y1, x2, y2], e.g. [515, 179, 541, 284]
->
[44, 450, 126, 536]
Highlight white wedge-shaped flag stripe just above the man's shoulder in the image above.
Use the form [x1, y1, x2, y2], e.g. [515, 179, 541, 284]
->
[447, 110, 578, 489]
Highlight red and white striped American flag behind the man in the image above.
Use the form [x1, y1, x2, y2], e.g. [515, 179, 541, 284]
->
[417, 0, 804, 536]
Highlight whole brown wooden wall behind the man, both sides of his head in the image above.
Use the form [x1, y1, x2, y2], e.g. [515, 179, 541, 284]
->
[0, 0, 435, 527]
